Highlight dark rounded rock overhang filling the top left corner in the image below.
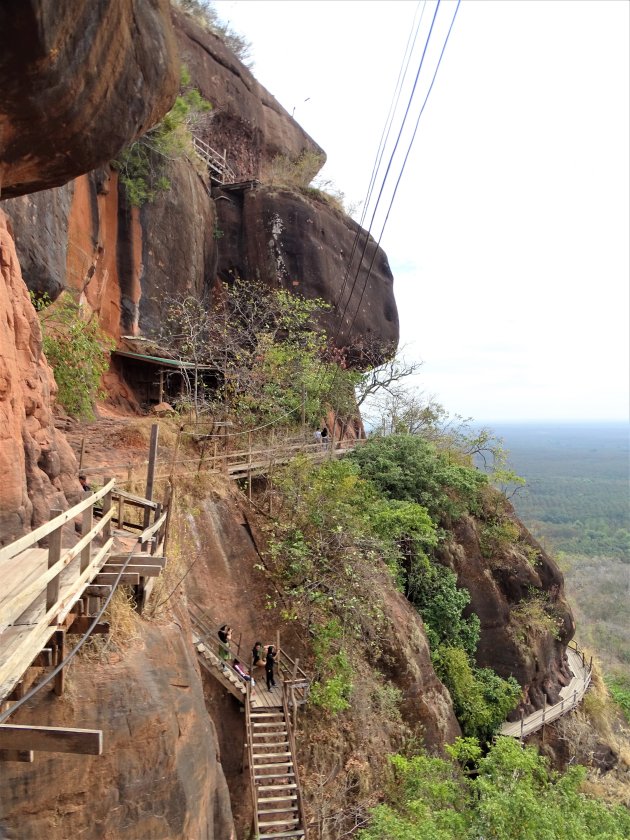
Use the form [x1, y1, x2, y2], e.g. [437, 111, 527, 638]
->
[0, 0, 179, 198]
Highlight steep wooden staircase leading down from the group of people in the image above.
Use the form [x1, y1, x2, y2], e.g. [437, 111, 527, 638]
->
[245, 684, 307, 840]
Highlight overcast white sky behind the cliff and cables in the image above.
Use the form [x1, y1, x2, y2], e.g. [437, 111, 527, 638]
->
[215, 0, 630, 422]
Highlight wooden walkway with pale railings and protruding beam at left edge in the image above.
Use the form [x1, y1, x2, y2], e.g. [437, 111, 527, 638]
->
[0, 479, 168, 761]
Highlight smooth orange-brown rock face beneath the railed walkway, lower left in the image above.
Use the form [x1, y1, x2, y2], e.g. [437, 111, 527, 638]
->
[0, 623, 236, 840]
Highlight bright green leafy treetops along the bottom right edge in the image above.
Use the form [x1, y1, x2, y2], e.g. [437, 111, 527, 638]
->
[359, 738, 630, 840]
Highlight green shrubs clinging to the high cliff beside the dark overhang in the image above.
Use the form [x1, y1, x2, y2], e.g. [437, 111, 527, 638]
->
[112, 68, 212, 207]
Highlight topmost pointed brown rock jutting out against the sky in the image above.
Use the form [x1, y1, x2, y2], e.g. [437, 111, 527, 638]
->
[173, 9, 326, 181]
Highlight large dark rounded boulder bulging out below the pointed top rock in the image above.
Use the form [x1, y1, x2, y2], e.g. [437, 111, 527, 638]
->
[216, 187, 398, 363]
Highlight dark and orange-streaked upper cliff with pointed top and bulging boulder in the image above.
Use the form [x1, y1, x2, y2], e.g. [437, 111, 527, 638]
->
[3, 6, 398, 363]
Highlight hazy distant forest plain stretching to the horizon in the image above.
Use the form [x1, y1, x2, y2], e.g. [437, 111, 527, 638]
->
[493, 423, 630, 680]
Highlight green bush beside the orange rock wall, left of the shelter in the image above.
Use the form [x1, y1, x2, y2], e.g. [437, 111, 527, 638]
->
[35, 292, 114, 419]
